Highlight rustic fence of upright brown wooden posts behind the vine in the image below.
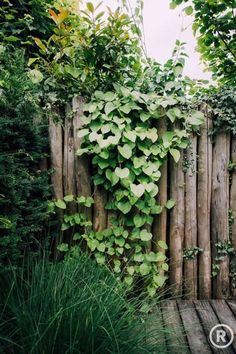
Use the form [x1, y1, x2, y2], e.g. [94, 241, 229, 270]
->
[49, 98, 236, 299]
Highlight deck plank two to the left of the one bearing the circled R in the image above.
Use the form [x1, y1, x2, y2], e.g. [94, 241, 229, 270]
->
[161, 300, 189, 354]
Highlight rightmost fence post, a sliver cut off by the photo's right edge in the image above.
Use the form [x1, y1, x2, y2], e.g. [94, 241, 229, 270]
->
[230, 137, 236, 298]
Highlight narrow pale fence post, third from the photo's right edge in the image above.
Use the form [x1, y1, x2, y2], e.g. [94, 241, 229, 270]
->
[197, 106, 212, 299]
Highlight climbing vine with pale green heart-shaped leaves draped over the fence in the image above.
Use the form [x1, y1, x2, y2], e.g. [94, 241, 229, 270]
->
[71, 85, 203, 295]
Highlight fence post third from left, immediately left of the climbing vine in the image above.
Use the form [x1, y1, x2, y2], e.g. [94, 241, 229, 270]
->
[72, 97, 92, 221]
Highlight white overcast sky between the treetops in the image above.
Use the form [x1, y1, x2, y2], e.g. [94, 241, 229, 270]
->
[90, 0, 211, 80]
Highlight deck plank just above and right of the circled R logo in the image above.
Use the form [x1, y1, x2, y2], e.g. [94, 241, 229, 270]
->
[211, 300, 236, 351]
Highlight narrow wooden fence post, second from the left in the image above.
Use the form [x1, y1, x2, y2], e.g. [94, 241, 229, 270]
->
[63, 104, 76, 213]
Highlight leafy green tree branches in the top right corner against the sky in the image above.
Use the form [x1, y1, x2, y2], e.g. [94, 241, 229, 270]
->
[171, 0, 236, 85]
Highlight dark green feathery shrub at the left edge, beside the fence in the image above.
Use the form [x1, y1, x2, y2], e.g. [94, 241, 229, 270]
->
[0, 47, 51, 272]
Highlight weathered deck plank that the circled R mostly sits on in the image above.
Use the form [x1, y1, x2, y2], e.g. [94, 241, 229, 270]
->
[194, 300, 234, 354]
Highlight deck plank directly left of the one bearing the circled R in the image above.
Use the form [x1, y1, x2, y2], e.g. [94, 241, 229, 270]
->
[177, 300, 212, 354]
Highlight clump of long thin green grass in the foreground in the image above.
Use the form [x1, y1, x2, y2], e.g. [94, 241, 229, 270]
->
[0, 257, 169, 354]
